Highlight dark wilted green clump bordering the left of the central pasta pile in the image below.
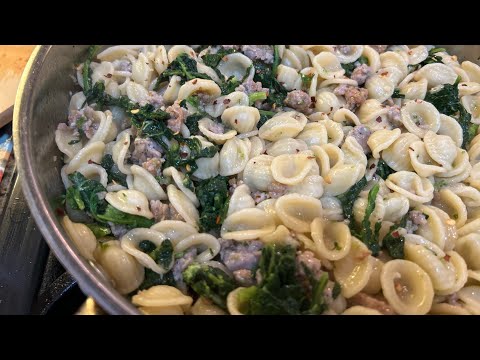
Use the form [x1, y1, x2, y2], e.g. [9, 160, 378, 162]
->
[196, 176, 229, 232]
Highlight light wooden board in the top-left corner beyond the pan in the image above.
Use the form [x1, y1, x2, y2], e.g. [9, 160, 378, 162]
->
[0, 45, 35, 114]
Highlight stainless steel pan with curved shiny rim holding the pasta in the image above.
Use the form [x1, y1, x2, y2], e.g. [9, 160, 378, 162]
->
[10, 45, 480, 314]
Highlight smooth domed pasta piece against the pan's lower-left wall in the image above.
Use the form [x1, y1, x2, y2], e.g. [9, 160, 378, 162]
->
[95, 240, 145, 295]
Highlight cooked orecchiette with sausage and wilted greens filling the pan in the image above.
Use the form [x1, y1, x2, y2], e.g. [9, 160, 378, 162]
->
[55, 45, 480, 315]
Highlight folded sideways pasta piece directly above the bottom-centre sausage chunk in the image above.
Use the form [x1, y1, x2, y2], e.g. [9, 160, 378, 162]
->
[221, 207, 274, 241]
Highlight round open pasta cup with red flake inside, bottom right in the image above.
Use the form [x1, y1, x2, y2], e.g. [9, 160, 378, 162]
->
[380, 259, 434, 315]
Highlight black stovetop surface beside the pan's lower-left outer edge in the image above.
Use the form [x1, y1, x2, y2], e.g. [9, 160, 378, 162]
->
[0, 122, 86, 315]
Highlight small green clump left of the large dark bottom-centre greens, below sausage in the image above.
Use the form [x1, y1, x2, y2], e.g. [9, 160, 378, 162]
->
[183, 263, 237, 309]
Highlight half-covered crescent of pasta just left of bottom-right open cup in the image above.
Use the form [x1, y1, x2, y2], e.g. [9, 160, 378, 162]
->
[333, 237, 373, 299]
